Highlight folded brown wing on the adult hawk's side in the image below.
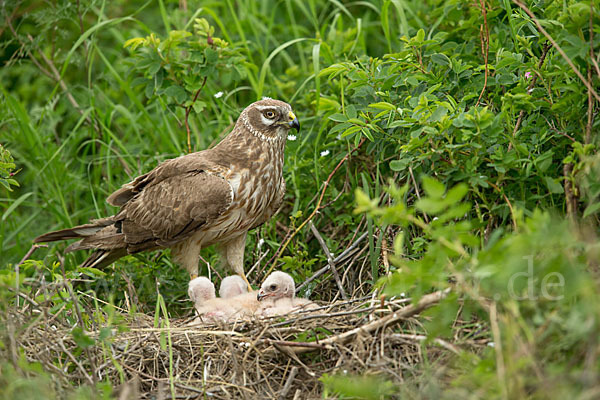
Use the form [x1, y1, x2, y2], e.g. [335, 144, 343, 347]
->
[115, 171, 233, 250]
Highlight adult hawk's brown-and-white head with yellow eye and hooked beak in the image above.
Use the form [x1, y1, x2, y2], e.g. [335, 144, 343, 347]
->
[240, 98, 300, 141]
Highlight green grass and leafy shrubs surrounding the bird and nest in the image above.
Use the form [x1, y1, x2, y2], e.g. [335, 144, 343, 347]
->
[0, 0, 600, 398]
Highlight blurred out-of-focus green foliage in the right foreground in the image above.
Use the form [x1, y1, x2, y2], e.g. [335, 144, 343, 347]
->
[357, 178, 600, 398]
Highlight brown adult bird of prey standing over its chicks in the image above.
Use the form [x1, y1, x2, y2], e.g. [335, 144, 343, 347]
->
[35, 99, 300, 287]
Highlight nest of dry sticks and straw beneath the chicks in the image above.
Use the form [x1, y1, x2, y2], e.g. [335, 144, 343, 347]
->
[0, 282, 474, 399]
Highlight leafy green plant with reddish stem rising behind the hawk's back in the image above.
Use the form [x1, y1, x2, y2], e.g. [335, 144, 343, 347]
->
[124, 18, 246, 152]
